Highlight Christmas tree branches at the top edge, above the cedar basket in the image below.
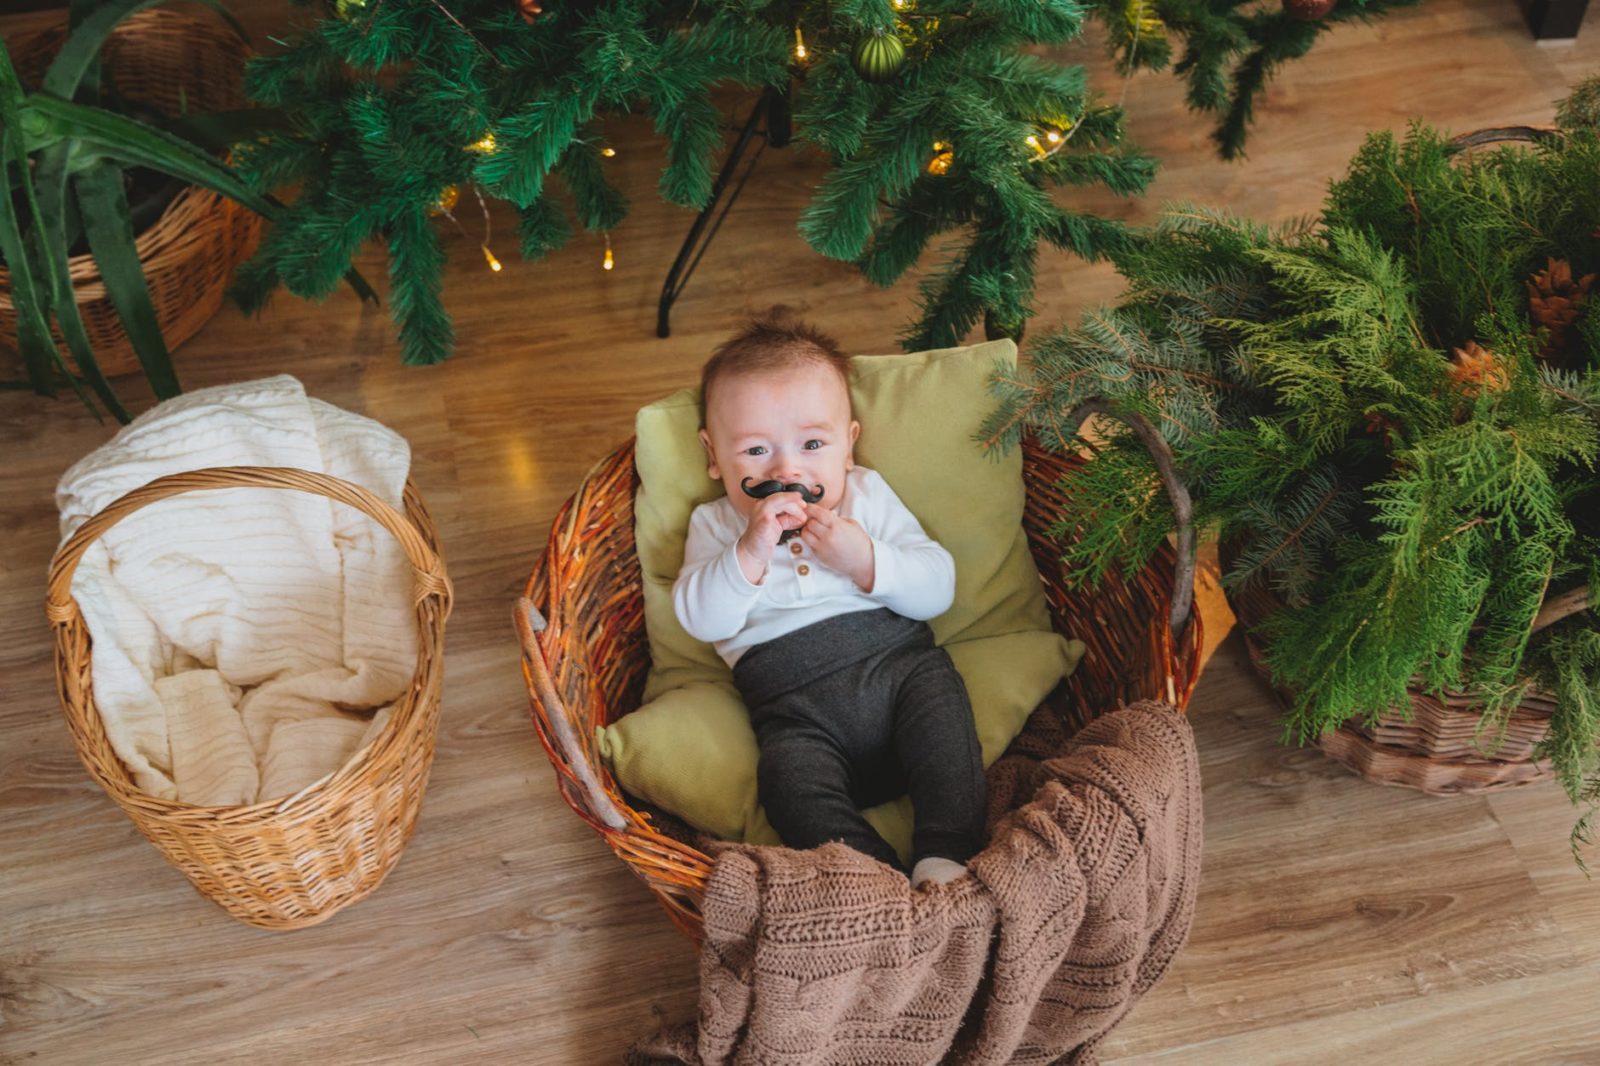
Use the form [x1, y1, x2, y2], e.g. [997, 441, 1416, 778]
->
[1088, 0, 1419, 160]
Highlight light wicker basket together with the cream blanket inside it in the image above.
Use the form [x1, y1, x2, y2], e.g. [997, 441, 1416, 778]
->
[48, 376, 451, 928]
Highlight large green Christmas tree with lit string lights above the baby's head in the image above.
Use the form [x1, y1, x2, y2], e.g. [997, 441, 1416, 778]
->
[237, 0, 1155, 363]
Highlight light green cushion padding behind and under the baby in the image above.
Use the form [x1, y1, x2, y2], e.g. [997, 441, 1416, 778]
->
[600, 341, 1083, 858]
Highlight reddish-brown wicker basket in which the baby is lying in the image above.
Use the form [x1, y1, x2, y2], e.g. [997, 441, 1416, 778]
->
[517, 439, 1200, 941]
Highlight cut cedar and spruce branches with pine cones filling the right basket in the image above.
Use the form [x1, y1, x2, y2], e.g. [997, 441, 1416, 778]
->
[984, 89, 1600, 848]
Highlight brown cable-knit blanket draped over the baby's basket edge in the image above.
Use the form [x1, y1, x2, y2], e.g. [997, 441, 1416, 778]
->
[627, 701, 1200, 1066]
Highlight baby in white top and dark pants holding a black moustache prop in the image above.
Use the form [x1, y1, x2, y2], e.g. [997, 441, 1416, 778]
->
[672, 320, 984, 885]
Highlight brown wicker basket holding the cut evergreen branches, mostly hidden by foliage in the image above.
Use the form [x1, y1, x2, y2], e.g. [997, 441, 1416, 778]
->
[1224, 560, 1555, 795]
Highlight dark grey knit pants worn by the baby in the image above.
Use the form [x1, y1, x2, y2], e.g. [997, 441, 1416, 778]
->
[733, 608, 984, 866]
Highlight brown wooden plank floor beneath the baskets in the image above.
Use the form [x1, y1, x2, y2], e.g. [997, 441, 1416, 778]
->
[0, 0, 1600, 1066]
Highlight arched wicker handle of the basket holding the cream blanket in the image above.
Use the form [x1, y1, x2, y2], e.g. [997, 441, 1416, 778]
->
[45, 466, 453, 626]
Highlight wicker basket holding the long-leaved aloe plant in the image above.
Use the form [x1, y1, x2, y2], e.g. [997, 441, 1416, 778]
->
[0, 10, 262, 376]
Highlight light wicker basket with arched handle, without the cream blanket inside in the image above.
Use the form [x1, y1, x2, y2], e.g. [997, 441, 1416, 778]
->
[46, 467, 451, 928]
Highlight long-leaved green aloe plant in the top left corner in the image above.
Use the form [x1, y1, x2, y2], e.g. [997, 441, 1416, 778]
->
[0, 0, 374, 423]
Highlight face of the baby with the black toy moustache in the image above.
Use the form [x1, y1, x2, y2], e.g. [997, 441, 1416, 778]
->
[701, 363, 861, 517]
